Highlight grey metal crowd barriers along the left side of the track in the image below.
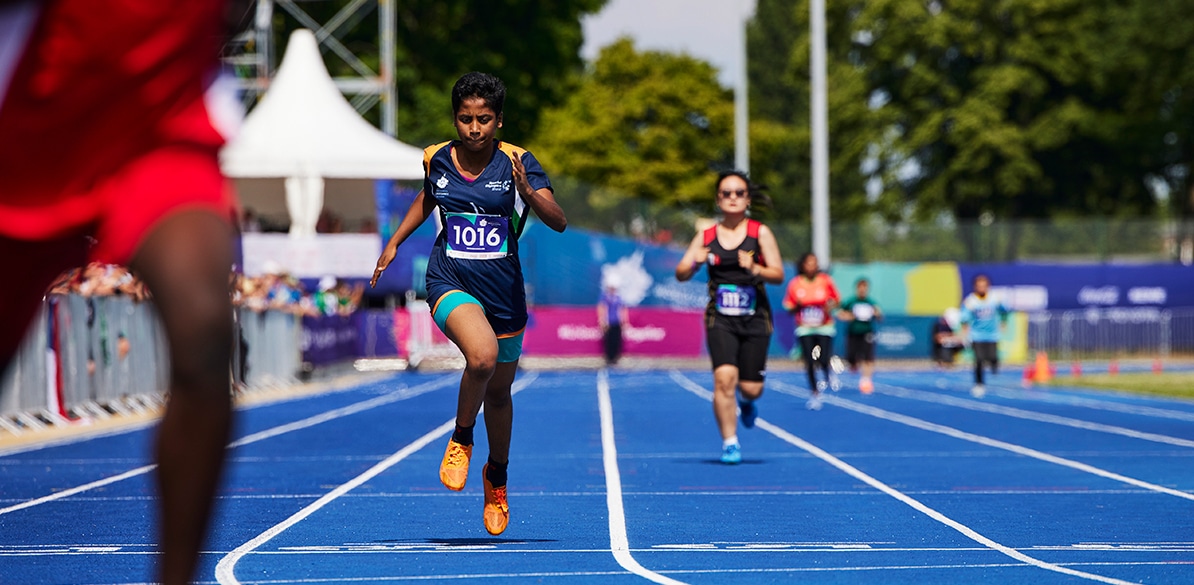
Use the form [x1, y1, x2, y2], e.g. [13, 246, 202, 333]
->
[0, 295, 301, 433]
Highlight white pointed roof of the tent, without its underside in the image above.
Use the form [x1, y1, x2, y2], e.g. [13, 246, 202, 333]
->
[220, 29, 423, 179]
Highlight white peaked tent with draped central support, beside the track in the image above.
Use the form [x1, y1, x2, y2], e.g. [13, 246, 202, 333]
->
[220, 29, 423, 235]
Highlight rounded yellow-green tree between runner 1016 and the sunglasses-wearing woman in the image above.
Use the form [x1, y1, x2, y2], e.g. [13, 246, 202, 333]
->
[529, 38, 733, 209]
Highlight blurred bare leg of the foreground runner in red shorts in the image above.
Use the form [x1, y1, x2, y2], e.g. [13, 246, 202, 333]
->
[131, 211, 233, 585]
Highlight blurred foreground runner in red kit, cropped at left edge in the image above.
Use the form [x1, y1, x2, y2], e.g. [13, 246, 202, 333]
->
[0, 0, 242, 584]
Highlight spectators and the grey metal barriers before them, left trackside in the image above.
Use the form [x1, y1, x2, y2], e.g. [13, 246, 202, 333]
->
[0, 263, 370, 433]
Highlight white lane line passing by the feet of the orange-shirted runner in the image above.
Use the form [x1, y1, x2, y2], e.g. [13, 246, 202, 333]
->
[771, 382, 1194, 501]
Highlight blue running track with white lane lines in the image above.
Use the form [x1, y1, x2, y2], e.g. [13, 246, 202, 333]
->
[0, 370, 1194, 585]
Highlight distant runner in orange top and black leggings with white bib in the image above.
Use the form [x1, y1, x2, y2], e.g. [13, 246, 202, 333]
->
[783, 253, 842, 411]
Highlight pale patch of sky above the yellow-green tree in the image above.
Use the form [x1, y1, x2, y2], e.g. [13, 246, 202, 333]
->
[580, 0, 755, 87]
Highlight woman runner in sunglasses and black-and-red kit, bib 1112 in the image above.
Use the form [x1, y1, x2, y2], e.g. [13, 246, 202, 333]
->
[676, 171, 783, 463]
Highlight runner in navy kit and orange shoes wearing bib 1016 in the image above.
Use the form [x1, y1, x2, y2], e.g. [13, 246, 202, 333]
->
[370, 72, 568, 535]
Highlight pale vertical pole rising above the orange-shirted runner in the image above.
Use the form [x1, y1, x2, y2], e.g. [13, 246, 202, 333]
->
[810, 0, 830, 266]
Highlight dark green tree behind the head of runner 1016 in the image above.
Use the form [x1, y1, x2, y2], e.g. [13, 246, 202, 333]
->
[256, 0, 607, 144]
